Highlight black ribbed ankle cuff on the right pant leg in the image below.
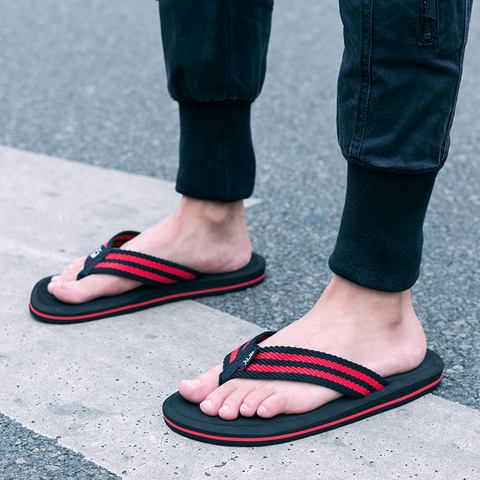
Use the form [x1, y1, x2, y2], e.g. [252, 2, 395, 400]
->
[329, 163, 437, 292]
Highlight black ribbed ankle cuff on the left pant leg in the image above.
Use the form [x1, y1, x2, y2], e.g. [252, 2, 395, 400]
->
[176, 101, 255, 202]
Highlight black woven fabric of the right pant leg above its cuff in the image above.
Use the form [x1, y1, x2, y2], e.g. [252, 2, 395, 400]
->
[337, 0, 472, 173]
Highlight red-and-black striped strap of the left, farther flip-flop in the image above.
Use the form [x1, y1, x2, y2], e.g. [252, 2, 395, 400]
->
[77, 231, 202, 286]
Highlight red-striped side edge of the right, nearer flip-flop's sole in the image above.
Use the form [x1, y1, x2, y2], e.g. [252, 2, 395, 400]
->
[163, 376, 442, 442]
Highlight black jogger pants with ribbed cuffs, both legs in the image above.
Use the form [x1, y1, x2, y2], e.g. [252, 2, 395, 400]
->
[159, 0, 472, 291]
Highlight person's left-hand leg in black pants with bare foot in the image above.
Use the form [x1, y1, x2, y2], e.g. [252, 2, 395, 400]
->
[35, 0, 272, 303]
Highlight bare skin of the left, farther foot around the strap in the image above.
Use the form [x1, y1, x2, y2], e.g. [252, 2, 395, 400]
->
[48, 197, 252, 303]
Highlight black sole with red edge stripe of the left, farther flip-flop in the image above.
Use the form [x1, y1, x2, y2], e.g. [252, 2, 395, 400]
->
[30, 253, 265, 323]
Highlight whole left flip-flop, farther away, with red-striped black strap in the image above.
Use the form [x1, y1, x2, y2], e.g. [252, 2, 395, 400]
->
[30, 231, 265, 323]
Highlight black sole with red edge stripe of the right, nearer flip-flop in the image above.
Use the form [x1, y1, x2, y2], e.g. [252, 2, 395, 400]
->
[163, 350, 444, 447]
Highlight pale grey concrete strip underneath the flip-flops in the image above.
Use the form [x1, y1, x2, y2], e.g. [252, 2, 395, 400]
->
[0, 147, 480, 480]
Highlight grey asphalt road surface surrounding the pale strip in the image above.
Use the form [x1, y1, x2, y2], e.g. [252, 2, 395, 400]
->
[0, 0, 480, 479]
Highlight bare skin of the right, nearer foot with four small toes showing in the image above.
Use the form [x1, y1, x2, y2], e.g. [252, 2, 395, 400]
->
[179, 275, 426, 420]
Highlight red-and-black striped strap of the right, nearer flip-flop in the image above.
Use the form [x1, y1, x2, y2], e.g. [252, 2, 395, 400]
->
[219, 332, 389, 398]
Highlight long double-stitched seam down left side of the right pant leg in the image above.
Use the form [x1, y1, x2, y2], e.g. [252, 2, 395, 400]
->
[351, 0, 373, 158]
